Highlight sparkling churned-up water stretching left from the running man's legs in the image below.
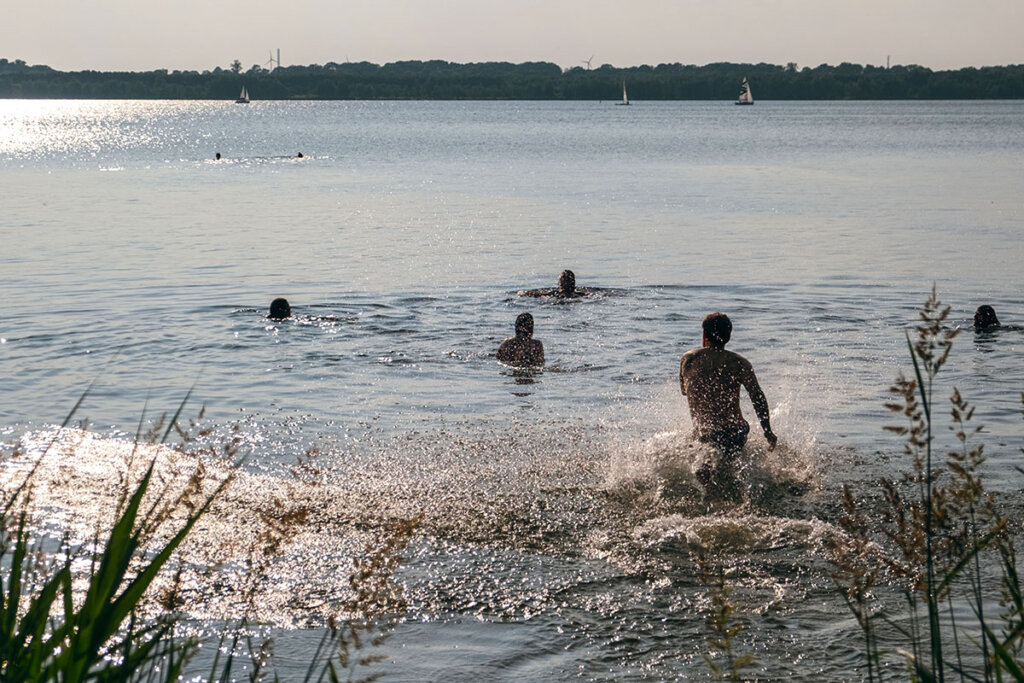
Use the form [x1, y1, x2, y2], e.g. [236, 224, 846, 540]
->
[4, 403, 814, 626]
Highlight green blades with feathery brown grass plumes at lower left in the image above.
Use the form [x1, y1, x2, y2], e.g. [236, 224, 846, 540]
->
[0, 392, 418, 683]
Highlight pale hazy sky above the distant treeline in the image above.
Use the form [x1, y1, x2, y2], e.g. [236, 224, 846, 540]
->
[0, 0, 1024, 71]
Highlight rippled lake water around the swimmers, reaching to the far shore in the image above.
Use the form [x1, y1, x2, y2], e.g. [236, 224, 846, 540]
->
[0, 100, 1024, 680]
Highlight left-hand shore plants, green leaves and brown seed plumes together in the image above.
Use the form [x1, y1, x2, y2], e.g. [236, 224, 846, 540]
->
[0, 390, 419, 683]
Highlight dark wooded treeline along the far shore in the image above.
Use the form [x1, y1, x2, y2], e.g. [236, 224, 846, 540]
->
[0, 59, 1024, 100]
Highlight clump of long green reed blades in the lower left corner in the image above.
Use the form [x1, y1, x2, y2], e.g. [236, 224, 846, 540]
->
[0, 392, 231, 682]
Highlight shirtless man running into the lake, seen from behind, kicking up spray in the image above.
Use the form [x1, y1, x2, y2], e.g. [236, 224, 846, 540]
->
[679, 313, 778, 488]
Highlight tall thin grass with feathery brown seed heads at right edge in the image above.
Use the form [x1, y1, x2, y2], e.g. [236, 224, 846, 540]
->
[829, 288, 1024, 682]
